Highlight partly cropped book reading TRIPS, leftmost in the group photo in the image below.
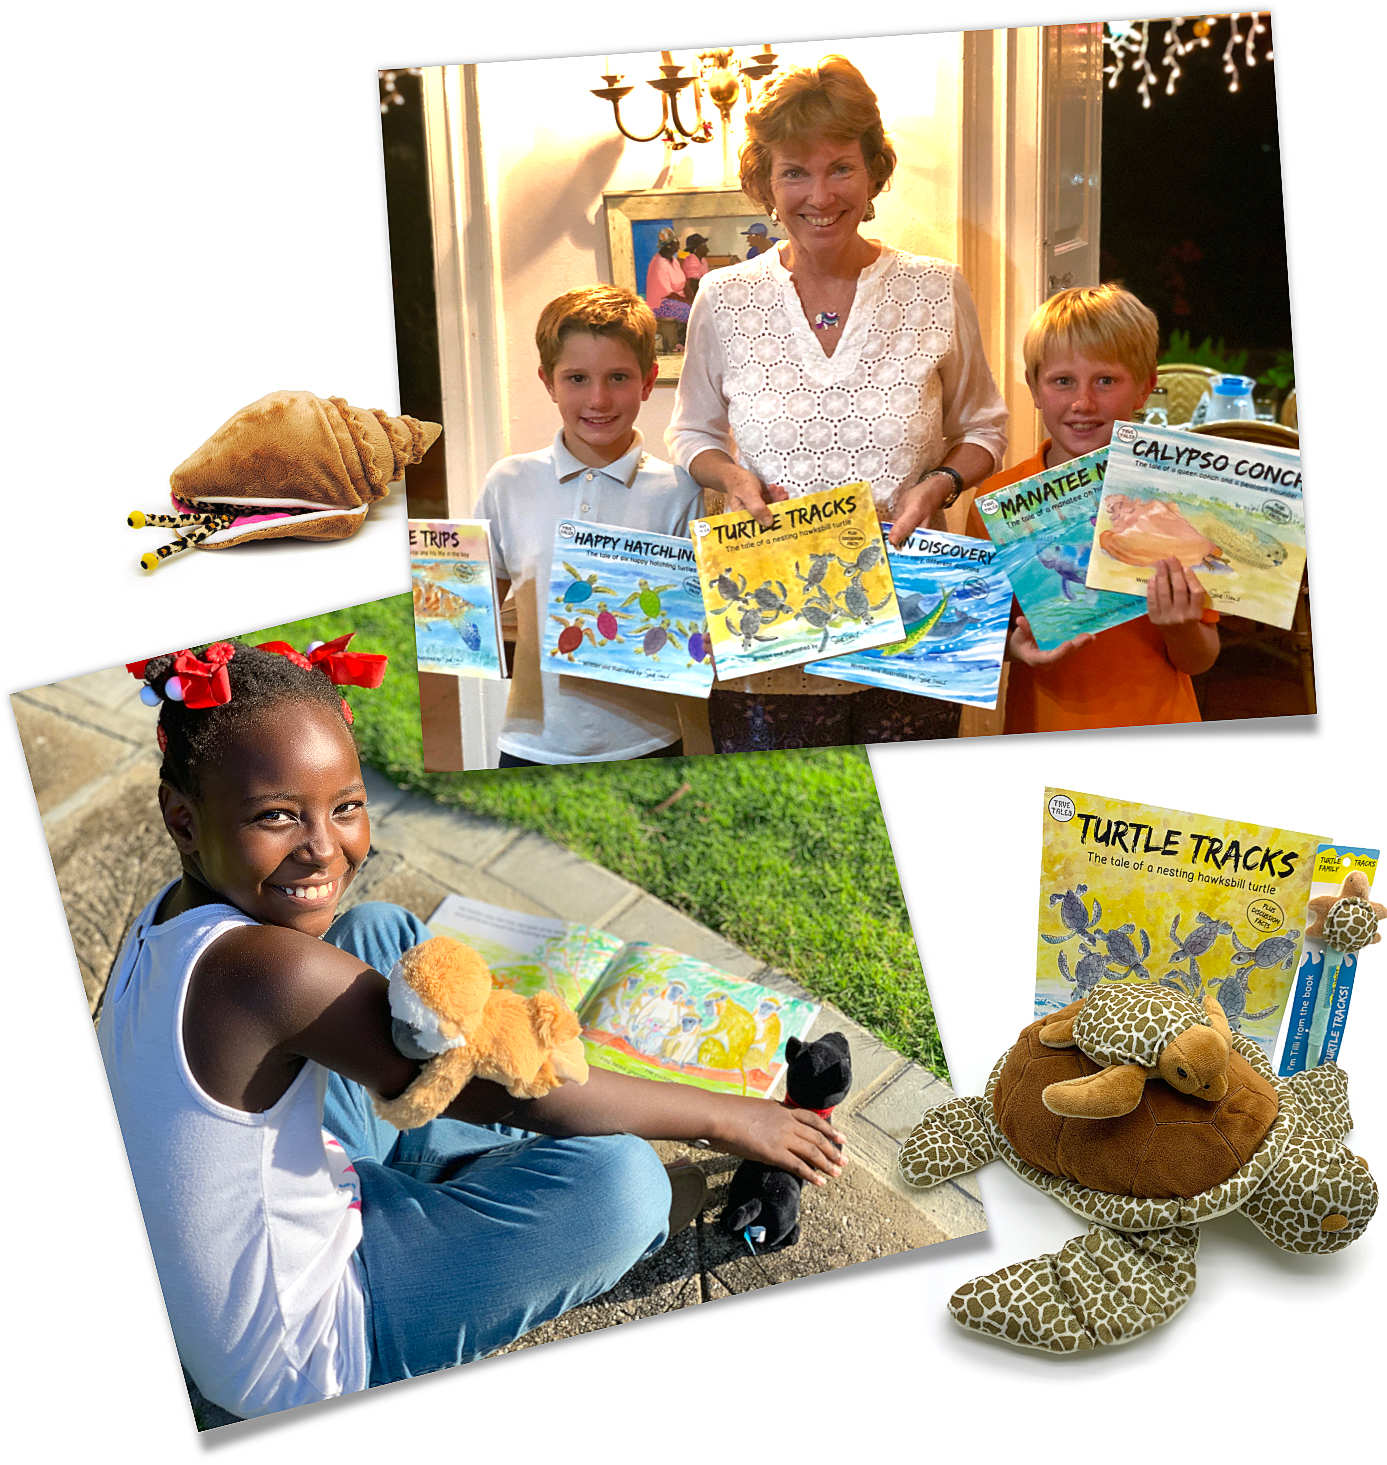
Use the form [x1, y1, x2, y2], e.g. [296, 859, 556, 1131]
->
[409, 519, 505, 681]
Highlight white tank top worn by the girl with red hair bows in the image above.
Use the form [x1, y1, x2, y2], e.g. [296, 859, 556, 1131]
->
[98, 891, 369, 1417]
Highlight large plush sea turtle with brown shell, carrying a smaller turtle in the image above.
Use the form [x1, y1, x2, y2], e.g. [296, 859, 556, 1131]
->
[899, 996, 1377, 1354]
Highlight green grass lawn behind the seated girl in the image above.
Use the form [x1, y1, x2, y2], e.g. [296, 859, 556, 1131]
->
[248, 595, 948, 1078]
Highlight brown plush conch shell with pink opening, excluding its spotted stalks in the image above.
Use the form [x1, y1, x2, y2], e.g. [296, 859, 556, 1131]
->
[168, 391, 442, 549]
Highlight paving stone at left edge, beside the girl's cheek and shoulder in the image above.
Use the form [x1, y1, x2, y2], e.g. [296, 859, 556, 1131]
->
[48, 760, 179, 1012]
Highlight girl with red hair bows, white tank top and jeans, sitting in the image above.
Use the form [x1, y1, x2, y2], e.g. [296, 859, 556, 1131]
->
[100, 637, 842, 1417]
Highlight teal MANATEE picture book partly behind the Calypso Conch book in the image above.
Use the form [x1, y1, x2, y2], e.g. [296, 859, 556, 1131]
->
[974, 448, 1147, 650]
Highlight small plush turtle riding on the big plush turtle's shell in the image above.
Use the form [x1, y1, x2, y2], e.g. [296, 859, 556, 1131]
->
[1038, 982, 1233, 1119]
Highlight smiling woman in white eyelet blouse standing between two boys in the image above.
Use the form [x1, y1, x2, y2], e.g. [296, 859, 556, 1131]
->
[666, 56, 1006, 752]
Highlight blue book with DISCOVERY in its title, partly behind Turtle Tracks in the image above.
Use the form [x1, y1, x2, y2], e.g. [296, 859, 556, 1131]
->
[806, 526, 1012, 708]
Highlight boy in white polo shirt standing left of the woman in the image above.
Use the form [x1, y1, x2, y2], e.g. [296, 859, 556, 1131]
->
[476, 286, 699, 768]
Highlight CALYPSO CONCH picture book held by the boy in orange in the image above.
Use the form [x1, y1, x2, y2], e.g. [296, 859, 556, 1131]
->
[1088, 422, 1305, 630]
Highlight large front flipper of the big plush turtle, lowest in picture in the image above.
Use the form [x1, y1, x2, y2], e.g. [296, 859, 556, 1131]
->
[949, 1226, 1200, 1354]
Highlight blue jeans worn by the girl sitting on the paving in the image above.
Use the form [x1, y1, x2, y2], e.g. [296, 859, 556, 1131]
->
[322, 902, 669, 1384]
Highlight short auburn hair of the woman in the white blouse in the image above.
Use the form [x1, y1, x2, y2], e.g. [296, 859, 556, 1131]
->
[740, 56, 896, 214]
